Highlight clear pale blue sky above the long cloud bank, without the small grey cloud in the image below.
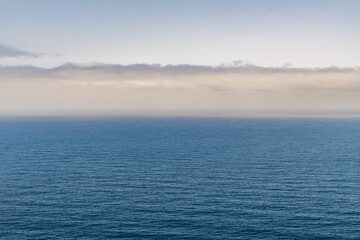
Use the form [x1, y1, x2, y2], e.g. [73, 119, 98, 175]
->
[0, 0, 360, 67]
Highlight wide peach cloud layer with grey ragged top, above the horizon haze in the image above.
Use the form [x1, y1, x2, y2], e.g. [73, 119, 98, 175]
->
[0, 63, 360, 112]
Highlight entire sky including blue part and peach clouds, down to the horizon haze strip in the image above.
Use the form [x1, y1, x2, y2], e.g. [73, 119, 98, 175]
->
[0, 0, 360, 114]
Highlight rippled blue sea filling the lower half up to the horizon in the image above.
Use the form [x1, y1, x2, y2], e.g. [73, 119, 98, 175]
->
[0, 118, 360, 239]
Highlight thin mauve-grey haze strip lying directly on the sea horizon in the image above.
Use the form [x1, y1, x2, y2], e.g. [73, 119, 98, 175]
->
[0, 109, 360, 119]
